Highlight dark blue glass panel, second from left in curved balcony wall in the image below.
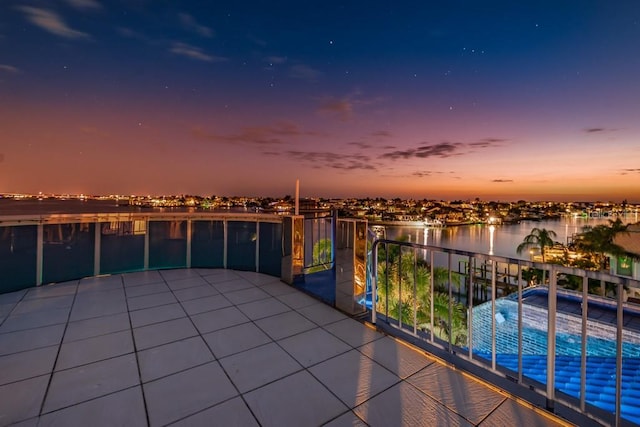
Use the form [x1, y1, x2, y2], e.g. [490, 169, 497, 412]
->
[42, 223, 95, 283]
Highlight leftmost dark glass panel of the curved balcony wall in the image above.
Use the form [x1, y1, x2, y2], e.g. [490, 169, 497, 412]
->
[0, 225, 38, 294]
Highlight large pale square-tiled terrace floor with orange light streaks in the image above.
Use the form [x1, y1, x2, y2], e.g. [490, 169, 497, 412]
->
[0, 269, 560, 427]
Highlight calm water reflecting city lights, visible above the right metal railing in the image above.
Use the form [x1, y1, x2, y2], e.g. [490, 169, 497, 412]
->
[385, 215, 640, 260]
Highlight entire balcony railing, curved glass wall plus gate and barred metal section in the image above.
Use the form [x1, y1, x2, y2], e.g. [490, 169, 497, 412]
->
[0, 213, 640, 424]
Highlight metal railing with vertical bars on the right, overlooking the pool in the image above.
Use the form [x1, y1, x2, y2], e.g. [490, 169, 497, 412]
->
[366, 240, 640, 425]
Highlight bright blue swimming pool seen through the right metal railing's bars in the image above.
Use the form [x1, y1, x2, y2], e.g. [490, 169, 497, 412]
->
[472, 297, 640, 424]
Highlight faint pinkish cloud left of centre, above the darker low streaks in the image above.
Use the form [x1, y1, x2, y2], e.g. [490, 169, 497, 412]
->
[191, 121, 323, 146]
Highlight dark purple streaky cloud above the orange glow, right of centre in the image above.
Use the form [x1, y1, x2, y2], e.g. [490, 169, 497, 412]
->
[380, 138, 507, 160]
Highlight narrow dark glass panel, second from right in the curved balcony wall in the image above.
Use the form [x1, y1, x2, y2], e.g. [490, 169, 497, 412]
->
[227, 221, 257, 271]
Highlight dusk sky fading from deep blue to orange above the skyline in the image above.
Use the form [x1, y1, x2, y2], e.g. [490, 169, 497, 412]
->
[0, 0, 640, 202]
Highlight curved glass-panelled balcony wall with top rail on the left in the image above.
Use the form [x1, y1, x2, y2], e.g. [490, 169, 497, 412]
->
[0, 213, 283, 293]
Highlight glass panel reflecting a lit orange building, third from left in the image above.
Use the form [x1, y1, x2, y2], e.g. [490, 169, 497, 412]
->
[100, 220, 147, 274]
